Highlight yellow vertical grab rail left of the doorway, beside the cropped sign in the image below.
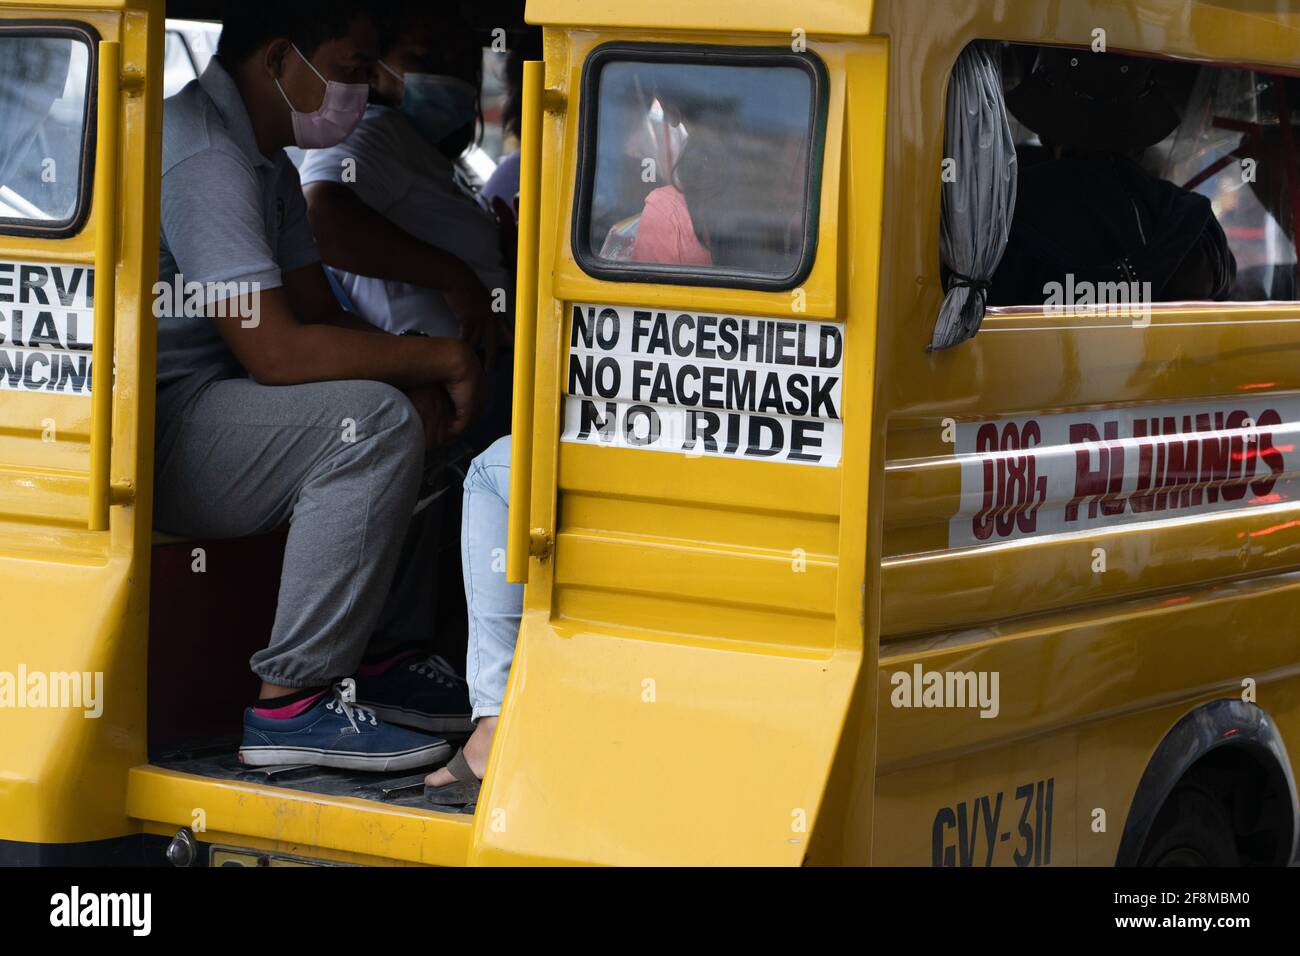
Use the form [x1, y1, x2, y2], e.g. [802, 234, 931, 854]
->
[90, 40, 122, 531]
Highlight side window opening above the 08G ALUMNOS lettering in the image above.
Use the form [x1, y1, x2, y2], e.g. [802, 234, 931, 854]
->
[939, 42, 1300, 347]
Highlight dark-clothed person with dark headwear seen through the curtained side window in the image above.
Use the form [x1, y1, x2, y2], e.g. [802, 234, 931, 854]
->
[988, 48, 1236, 306]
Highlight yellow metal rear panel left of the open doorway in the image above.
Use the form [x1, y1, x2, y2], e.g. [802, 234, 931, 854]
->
[0, 0, 163, 843]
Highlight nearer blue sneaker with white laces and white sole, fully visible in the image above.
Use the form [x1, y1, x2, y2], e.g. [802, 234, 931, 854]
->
[239, 685, 451, 770]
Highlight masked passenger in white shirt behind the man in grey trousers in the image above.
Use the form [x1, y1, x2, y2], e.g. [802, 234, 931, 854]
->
[300, 0, 514, 358]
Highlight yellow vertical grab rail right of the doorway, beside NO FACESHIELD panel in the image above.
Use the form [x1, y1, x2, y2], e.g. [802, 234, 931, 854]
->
[506, 60, 546, 584]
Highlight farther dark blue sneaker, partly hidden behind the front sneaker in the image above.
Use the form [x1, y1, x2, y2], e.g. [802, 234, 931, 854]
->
[356, 654, 475, 734]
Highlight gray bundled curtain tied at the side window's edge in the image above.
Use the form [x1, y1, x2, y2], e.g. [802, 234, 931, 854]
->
[930, 42, 1015, 350]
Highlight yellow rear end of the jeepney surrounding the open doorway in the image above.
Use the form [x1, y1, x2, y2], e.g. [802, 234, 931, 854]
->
[0, 0, 888, 865]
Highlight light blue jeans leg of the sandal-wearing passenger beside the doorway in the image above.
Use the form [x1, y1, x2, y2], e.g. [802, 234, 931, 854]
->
[460, 434, 524, 721]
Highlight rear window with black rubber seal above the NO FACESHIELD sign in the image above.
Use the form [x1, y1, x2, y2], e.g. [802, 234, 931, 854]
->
[573, 44, 826, 289]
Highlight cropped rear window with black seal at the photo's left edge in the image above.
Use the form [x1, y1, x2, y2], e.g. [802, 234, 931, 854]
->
[0, 26, 92, 237]
